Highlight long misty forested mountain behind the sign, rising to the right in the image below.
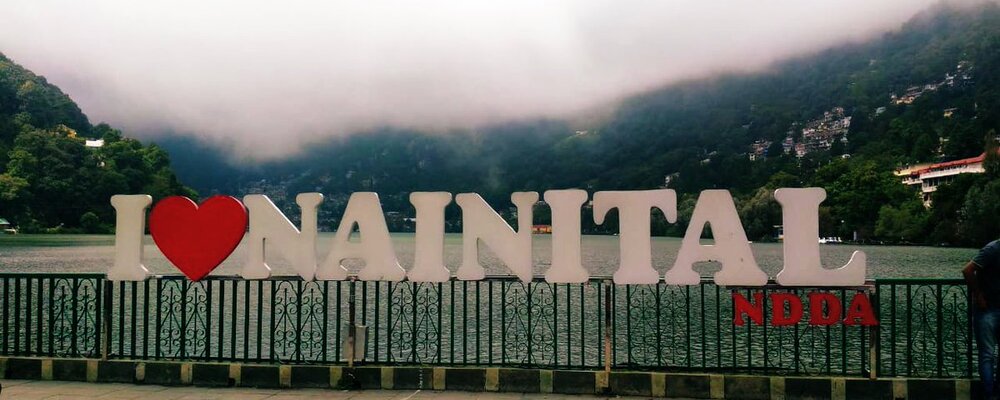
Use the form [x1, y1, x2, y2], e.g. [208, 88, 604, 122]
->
[158, 4, 1000, 245]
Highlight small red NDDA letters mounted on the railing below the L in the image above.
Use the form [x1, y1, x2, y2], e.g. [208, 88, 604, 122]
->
[733, 292, 878, 326]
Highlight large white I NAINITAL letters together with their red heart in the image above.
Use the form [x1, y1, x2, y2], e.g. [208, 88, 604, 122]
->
[108, 188, 866, 286]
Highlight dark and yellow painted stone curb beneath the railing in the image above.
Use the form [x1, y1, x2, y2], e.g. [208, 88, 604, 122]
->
[0, 357, 978, 400]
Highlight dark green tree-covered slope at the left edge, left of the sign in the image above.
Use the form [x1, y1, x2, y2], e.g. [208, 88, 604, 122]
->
[0, 54, 195, 232]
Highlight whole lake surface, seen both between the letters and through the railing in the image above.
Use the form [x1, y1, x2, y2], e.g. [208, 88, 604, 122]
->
[0, 233, 976, 376]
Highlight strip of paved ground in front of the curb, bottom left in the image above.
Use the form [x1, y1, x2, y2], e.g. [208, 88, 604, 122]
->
[0, 380, 656, 400]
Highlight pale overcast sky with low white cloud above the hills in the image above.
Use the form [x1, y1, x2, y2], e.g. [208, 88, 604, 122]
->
[0, 0, 948, 159]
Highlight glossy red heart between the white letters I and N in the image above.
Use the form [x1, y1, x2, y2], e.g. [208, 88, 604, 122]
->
[149, 196, 247, 281]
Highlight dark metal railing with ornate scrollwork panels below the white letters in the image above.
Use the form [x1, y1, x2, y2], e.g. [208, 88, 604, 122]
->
[0, 274, 974, 377]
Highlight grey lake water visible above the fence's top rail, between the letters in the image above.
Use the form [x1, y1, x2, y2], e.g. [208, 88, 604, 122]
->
[0, 233, 976, 278]
